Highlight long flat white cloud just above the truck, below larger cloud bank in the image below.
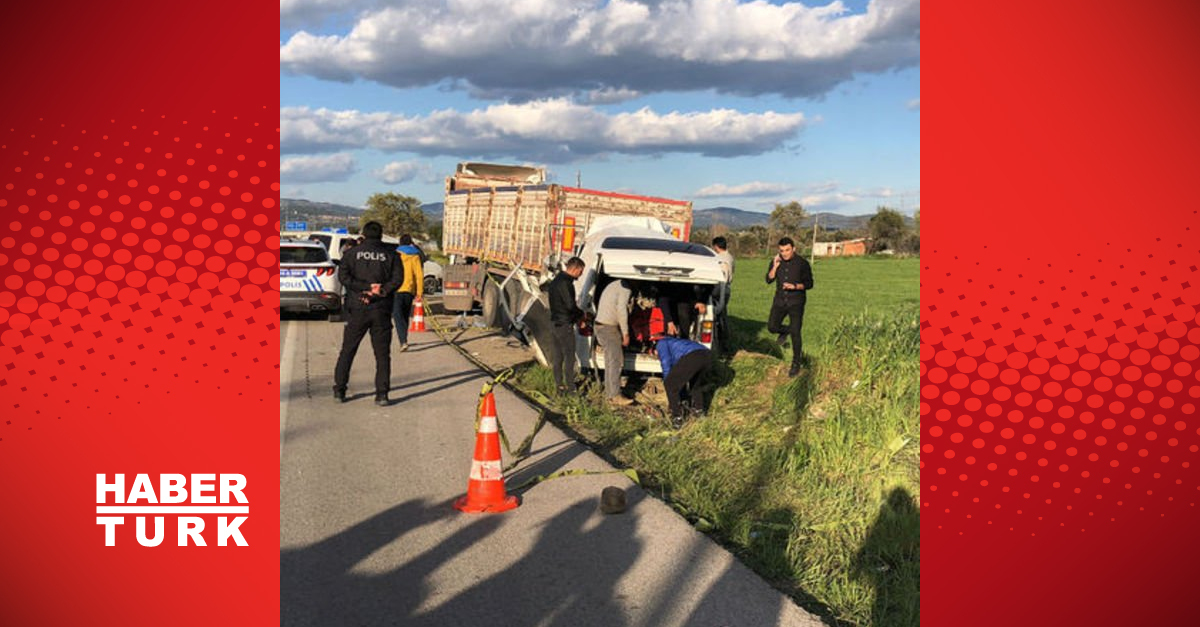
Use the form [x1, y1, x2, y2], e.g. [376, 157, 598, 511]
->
[280, 98, 804, 163]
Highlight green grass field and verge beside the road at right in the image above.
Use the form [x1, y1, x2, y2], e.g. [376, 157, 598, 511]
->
[518, 258, 920, 626]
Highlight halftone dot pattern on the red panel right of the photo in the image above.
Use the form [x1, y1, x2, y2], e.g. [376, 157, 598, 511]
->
[920, 219, 1200, 535]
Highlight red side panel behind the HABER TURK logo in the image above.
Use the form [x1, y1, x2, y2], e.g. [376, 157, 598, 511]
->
[0, 1, 278, 625]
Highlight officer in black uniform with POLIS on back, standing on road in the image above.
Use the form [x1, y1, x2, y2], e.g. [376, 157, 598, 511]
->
[334, 222, 403, 407]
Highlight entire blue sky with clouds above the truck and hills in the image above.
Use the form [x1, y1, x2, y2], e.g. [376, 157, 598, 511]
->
[280, 0, 920, 214]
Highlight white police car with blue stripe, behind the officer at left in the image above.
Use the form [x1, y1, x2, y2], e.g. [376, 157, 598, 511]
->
[280, 239, 342, 314]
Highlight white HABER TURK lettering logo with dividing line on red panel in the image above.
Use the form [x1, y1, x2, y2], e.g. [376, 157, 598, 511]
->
[96, 473, 250, 547]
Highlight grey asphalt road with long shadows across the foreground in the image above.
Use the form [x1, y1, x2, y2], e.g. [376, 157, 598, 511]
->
[280, 321, 821, 627]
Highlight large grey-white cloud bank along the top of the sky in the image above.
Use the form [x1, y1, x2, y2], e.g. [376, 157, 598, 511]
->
[280, 0, 920, 101]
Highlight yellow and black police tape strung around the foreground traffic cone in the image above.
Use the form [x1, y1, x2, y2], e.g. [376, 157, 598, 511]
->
[428, 307, 642, 491]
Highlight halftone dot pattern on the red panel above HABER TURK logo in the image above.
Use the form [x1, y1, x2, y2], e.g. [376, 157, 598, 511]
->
[0, 106, 280, 439]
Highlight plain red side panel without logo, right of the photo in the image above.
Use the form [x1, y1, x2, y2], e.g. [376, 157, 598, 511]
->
[920, 2, 1200, 626]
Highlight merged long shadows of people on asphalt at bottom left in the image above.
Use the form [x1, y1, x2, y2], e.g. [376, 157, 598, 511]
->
[280, 490, 642, 627]
